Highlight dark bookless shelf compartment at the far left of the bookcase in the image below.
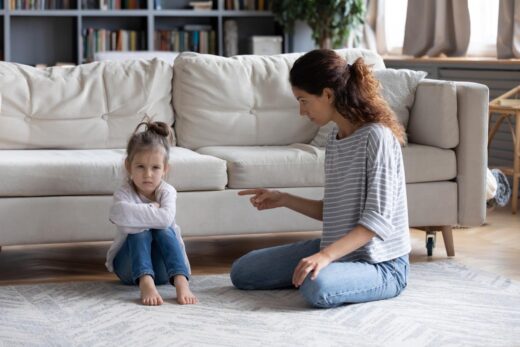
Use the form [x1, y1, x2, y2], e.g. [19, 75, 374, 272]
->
[10, 16, 77, 65]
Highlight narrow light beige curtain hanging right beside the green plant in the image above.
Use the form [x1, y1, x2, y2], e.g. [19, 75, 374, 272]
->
[362, 0, 388, 54]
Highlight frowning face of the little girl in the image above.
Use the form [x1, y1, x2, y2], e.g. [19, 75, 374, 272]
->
[125, 148, 169, 200]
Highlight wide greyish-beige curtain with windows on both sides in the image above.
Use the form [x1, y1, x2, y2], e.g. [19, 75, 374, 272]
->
[403, 0, 470, 57]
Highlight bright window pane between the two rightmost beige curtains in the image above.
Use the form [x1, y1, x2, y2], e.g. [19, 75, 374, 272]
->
[467, 0, 498, 57]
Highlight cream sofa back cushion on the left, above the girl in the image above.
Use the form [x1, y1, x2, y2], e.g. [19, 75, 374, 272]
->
[0, 59, 173, 149]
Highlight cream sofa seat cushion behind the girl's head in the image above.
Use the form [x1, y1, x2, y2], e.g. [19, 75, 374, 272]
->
[0, 147, 227, 197]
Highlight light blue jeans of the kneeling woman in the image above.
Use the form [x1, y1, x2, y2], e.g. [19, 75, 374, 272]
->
[231, 239, 409, 308]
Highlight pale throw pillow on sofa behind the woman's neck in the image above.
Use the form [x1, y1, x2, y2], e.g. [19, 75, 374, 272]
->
[310, 69, 427, 147]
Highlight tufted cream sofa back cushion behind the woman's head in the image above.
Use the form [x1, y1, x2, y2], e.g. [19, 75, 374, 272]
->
[173, 49, 384, 149]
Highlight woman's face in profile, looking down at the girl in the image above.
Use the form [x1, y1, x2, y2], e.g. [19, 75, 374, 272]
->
[292, 87, 335, 126]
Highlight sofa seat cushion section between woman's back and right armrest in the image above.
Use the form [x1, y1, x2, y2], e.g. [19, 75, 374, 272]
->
[402, 143, 457, 183]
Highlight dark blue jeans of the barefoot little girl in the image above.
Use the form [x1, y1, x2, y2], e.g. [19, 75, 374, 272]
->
[114, 228, 190, 284]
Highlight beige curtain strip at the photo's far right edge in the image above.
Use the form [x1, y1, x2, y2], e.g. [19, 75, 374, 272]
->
[497, 0, 520, 59]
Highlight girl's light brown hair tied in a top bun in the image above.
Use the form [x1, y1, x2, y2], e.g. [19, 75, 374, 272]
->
[126, 119, 173, 164]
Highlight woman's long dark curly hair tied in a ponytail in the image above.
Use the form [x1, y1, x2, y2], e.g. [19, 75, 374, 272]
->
[289, 49, 405, 144]
